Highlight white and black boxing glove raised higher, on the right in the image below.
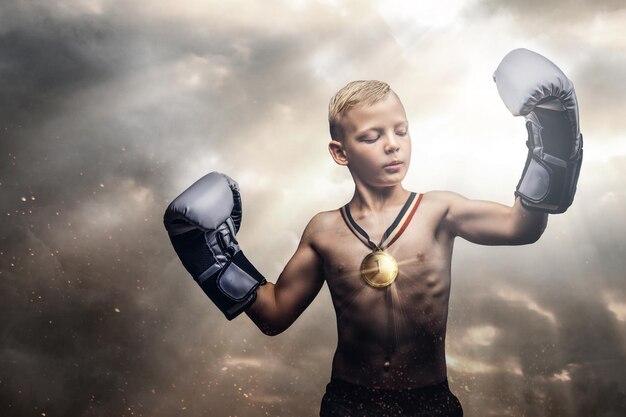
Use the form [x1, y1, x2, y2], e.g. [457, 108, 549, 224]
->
[493, 48, 583, 213]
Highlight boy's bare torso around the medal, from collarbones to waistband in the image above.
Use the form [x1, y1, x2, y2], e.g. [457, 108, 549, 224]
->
[312, 193, 454, 389]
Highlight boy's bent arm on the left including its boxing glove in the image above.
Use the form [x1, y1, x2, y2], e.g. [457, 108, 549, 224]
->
[163, 172, 324, 326]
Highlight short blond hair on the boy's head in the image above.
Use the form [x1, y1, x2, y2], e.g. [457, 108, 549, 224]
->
[328, 80, 393, 140]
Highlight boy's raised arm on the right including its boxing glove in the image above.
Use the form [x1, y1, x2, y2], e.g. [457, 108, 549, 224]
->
[438, 49, 582, 245]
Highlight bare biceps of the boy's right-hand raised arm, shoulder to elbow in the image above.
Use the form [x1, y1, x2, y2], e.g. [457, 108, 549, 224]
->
[448, 198, 515, 245]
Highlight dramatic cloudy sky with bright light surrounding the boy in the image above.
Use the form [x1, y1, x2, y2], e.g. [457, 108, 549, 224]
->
[0, 0, 626, 417]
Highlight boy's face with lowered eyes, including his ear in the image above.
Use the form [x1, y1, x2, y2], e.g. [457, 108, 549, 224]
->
[329, 92, 411, 187]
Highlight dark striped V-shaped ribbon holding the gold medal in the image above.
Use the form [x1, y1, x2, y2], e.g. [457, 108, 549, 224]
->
[341, 192, 422, 250]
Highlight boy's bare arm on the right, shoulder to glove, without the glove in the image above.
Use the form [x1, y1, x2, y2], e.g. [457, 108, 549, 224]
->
[442, 192, 548, 245]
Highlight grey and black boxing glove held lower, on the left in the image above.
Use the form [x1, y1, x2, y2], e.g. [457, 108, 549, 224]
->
[163, 172, 266, 320]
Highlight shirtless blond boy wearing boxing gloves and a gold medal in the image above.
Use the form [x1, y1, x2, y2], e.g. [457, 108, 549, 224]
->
[165, 50, 582, 417]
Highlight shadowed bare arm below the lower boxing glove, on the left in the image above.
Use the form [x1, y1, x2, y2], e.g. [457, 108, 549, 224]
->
[246, 215, 324, 336]
